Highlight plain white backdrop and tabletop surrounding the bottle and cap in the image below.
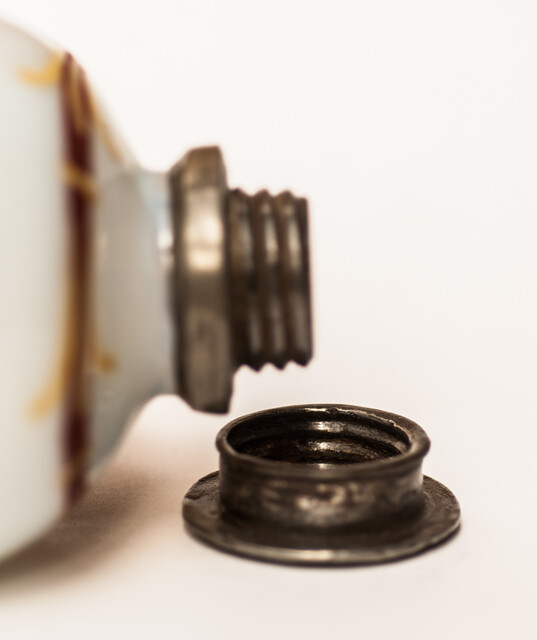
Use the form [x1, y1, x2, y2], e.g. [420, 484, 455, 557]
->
[0, 0, 537, 640]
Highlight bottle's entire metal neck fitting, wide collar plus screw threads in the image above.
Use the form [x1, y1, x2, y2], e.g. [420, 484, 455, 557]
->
[170, 147, 312, 412]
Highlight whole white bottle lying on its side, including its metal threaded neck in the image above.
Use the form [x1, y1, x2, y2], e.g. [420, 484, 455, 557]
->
[0, 22, 311, 558]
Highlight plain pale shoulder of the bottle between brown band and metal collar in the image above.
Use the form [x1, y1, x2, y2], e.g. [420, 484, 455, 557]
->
[90, 169, 173, 470]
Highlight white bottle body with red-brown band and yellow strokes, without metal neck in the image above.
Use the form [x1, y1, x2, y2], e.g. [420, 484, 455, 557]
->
[0, 23, 172, 557]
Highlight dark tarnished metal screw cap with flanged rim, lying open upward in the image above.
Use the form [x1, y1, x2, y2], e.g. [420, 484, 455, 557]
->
[183, 405, 460, 565]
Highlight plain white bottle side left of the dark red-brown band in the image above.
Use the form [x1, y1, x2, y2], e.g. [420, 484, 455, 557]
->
[0, 22, 67, 557]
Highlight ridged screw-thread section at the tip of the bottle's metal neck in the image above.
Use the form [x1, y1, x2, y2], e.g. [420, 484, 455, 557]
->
[227, 189, 312, 370]
